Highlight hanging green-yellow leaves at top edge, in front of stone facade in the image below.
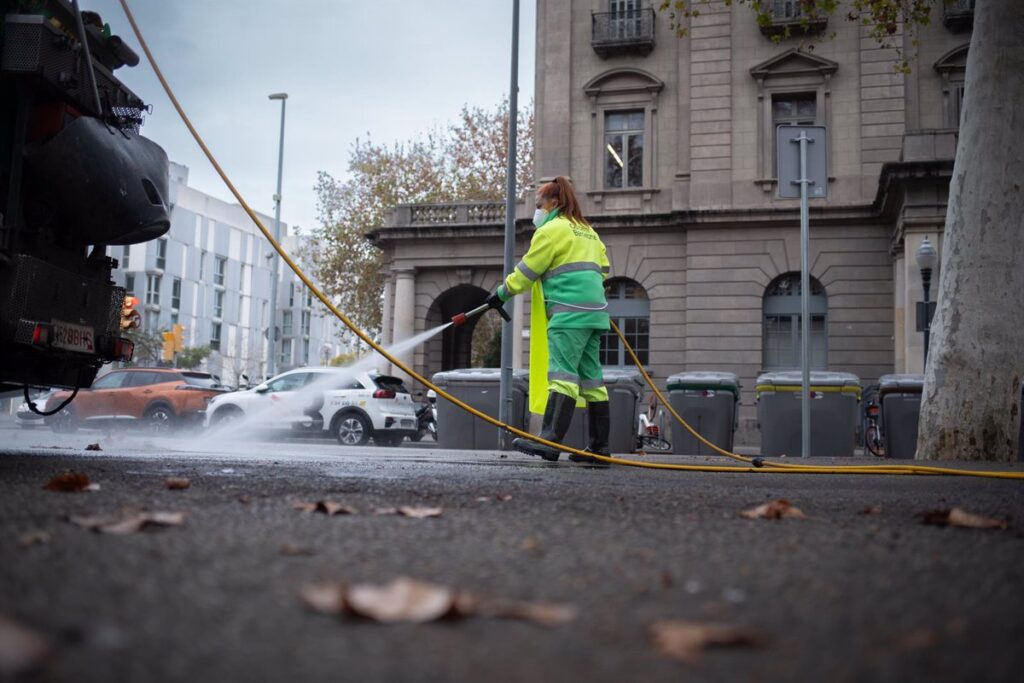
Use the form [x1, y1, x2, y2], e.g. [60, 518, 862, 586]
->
[659, 0, 947, 73]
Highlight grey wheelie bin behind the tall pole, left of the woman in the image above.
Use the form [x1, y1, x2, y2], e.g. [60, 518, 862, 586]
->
[432, 368, 529, 451]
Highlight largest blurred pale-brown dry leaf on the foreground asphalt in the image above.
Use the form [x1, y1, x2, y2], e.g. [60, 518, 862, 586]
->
[299, 577, 577, 627]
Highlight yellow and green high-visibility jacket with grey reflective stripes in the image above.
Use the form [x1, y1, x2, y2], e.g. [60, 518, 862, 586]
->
[499, 215, 610, 330]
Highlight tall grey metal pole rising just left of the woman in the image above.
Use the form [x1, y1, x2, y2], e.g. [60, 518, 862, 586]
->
[498, 0, 519, 451]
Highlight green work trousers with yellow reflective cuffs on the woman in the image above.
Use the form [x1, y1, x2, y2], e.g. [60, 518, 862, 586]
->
[548, 328, 608, 403]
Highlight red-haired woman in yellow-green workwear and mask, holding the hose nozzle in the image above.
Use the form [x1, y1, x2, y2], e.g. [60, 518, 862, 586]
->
[487, 176, 610, 465]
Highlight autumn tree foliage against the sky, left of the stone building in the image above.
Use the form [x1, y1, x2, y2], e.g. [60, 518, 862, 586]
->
[307, 100, 534, 334]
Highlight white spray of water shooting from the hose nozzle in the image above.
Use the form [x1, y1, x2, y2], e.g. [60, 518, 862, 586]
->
[179, 323, 452, 450]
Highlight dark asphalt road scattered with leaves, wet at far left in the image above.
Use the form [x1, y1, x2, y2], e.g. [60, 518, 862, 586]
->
[0, 421, 1024, 682]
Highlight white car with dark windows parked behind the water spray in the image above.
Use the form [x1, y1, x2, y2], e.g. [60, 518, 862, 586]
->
[206, 368, 416, 445]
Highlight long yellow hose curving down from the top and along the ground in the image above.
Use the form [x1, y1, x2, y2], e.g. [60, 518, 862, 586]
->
[120, 0, 1024, 479]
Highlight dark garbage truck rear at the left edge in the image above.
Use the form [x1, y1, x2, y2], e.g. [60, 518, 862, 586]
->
[0, 0, 170, 392]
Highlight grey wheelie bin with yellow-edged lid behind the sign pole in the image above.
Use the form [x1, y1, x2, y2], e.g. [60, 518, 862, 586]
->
[755, 371, 861, 458]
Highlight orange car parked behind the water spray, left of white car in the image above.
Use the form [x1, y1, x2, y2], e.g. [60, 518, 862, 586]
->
[46, 368, 225, 433]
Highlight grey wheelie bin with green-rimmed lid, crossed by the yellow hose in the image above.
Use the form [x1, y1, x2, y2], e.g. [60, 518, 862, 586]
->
[668, 372, 739, 456]
